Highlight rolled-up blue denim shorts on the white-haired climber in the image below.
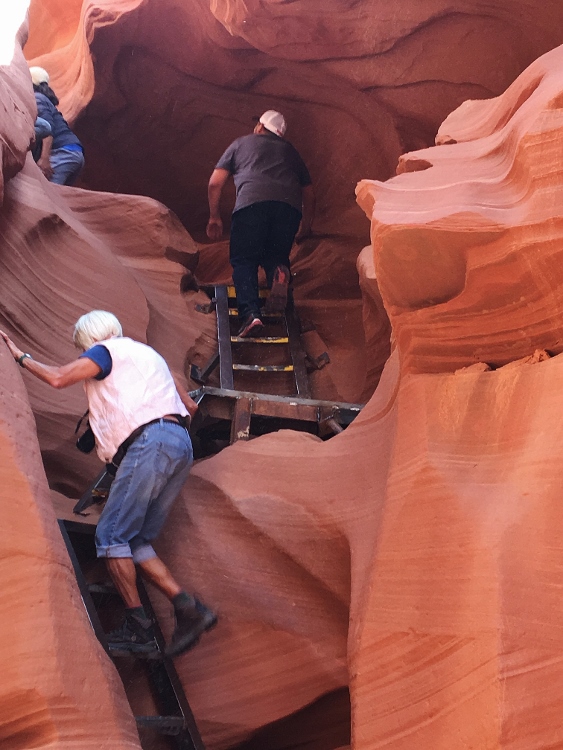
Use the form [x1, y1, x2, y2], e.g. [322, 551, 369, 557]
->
[96, 419, 193, 563]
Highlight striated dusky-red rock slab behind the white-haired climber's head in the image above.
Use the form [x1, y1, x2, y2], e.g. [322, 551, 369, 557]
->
[0, 157, 216, 497]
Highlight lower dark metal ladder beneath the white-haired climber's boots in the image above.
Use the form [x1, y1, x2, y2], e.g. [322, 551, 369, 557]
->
[59, 519, 205, 750]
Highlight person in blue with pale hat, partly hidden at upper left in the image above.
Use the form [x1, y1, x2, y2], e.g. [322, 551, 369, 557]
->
[29, 66, 84, 185]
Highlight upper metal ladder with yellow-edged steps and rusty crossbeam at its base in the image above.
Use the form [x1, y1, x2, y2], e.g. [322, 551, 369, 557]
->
[190, 285, 363, 457]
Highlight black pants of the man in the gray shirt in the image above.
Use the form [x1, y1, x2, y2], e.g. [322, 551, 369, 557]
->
[230, 201, 301, 320]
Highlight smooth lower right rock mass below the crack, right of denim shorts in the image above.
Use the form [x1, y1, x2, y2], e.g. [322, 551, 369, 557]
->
[161, 352, 563, 750]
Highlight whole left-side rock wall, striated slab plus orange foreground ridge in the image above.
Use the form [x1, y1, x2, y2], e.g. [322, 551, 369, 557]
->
[0, 13, 214, 750]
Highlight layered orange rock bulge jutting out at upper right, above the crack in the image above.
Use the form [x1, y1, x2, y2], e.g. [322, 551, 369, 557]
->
[357, 47, 563, 372]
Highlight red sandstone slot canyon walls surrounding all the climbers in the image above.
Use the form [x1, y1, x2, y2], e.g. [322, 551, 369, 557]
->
[0, 0, 563, 750]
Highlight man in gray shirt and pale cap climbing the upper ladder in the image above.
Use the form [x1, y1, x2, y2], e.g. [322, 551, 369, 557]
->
[207, 110, 315, 337]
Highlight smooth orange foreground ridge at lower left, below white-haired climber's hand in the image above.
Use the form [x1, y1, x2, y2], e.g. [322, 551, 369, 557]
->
[0, 324, 140, 750]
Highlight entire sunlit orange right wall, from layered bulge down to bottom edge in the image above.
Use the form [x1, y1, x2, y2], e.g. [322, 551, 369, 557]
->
[351, 42, 563, 750]
